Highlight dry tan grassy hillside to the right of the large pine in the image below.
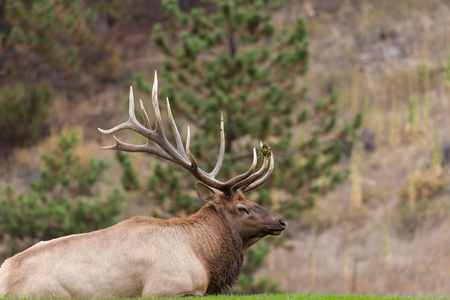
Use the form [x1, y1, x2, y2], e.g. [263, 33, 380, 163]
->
[260, 1, 450, 297]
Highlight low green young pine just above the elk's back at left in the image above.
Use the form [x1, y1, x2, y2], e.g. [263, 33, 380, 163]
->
[0, 131, 124, 255]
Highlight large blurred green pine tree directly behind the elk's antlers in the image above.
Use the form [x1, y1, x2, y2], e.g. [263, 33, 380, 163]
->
[128, 0, 361, 292]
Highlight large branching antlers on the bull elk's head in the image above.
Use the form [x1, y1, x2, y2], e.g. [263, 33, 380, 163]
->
[98, 71, 274, 197]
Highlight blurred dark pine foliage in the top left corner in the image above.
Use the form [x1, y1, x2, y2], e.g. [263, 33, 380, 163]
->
[0, 0, 96, 80]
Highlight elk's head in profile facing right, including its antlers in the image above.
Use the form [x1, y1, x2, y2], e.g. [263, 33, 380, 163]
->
[99, 72, 287, 239]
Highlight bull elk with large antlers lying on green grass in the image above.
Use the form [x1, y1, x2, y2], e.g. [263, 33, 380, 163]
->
[0, 72, 287, 298]
